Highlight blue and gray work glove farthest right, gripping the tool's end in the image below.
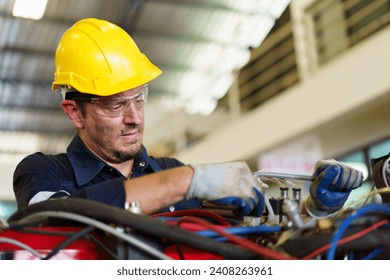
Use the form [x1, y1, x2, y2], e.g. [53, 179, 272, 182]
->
[306, 159, 363, 218]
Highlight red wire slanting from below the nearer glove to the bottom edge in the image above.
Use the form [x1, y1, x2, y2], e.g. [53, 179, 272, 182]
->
[178, 217, 296, 260]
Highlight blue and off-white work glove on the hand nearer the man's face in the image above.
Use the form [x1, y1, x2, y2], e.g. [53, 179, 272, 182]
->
[186, 161, 264, 216]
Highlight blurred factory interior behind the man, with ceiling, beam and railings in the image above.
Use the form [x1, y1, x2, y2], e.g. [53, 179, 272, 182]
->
[0, 0, 390, 217]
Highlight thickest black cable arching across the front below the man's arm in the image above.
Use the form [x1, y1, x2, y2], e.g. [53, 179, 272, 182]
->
[8, 198, 260, 259]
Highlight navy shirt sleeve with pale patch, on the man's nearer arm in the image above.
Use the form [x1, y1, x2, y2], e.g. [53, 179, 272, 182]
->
[13, 153, 125, 208]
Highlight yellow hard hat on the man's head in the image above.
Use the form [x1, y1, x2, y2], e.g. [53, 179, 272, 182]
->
[52, 18, 162, 96]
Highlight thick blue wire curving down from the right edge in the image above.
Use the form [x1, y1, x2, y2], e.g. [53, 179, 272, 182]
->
[326, 204, 390, 260]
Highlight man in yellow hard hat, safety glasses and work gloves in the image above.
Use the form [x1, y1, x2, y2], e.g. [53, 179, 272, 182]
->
[14, 18, 362, 219]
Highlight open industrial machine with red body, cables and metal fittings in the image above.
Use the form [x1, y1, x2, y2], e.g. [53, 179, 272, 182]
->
[0, 157, 390, 260]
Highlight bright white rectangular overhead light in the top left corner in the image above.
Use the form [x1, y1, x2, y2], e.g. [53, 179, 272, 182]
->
[12, 0, 47, 20]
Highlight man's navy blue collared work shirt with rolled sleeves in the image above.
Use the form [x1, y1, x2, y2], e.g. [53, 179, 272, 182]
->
[13, 135, 201, 212]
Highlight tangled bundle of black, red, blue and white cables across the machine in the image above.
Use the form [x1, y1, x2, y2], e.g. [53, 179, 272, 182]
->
[0, 199, 390, 260]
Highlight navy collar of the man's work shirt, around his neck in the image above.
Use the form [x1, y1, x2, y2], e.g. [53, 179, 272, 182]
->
[67, 135, 159, 186]
